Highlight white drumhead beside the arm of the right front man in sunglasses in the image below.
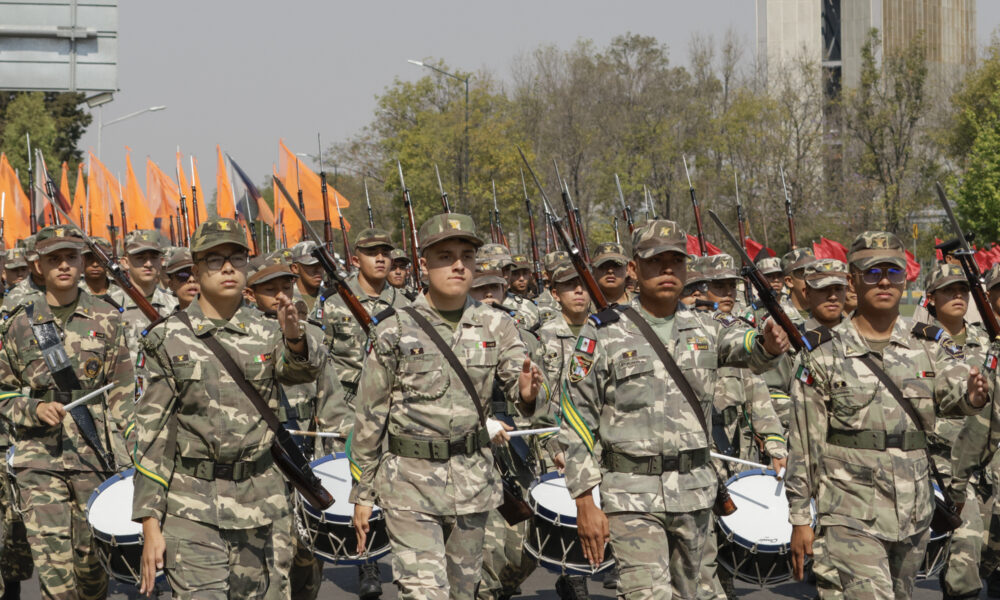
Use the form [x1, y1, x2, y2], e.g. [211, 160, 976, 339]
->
[721, 475, 792, 545]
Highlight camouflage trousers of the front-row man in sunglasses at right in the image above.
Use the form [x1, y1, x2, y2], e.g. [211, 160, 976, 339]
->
[823, 525, 930, 600]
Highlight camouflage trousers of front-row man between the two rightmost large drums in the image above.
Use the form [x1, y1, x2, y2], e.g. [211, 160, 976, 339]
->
[608, 508, 712, 600]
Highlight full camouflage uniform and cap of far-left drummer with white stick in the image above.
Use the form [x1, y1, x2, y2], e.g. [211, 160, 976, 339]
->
[0, 226, 134, 598]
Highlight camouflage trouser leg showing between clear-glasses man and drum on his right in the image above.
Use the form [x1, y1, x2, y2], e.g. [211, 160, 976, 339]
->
[267, 500, 323, 600]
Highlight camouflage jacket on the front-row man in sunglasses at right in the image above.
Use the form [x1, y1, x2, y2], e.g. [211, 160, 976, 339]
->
[785, 319, 976, 541]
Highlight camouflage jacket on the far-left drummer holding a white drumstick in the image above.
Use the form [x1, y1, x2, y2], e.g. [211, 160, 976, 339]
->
[0, 292, 135, 472]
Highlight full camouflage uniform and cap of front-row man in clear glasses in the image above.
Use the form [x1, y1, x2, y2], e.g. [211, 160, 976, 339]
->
[132, 219, 326, 598]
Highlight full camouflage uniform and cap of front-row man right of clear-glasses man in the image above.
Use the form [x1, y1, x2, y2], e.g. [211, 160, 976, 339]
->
[351, 213, 526, 599]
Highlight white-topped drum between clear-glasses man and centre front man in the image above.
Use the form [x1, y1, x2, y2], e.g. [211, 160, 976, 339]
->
[295, 452, 389, 565]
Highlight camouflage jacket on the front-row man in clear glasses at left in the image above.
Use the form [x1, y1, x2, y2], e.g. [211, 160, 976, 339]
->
[130, 302, 326, 529]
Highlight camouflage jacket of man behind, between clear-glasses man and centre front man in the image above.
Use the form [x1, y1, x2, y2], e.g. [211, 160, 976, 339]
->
[322, 277, 410, 392]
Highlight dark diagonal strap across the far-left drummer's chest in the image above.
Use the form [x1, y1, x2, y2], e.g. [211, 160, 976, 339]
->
[24, 304, 115, 473]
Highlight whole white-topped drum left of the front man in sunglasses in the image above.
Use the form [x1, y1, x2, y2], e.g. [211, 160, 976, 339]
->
[716, 469, 816, 587]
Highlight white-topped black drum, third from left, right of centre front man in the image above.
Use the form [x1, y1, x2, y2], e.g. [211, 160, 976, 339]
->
[524, 473, 615, 575]
